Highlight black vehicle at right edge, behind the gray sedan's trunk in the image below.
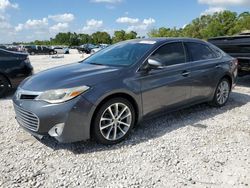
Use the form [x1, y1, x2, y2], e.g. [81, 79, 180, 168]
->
[208, 33, 250, 76]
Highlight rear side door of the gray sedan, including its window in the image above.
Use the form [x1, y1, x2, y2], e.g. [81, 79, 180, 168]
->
[185, 42, 221, 101]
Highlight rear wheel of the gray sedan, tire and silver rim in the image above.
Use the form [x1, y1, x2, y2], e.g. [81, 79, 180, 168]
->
[211, 78, 231, 107]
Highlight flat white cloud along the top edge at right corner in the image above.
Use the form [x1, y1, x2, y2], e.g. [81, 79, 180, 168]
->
[198, 0, 250, 6]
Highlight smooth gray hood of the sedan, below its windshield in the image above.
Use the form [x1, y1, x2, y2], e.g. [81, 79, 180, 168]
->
[20, 63, 121, 91]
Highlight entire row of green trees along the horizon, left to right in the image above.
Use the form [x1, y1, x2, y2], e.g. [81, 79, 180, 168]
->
[19, 11, 250, 46]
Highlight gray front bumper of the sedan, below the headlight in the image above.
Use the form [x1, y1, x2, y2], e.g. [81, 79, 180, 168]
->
[13, 95, 94, 143]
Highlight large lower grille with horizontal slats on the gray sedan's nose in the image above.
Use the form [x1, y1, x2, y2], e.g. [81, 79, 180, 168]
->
[14, 105, 39, 131]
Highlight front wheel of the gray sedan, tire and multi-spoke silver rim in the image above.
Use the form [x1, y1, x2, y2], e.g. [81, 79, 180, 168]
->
[92, 98, 135, 145]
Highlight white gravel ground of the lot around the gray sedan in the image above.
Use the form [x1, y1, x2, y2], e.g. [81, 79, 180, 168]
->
[0, 54, 250, 187]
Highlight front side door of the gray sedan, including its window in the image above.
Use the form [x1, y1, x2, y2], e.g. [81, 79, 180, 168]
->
[141, 42, 191, 114]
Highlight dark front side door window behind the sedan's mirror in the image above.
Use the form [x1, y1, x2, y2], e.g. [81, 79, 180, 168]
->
[151, 42, 186, 66]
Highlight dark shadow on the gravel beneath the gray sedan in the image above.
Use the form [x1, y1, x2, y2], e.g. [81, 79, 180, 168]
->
[40, 91, 250, 154]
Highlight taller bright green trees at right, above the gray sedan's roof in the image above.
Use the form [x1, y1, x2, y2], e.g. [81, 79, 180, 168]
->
[148, 11, 250, 40]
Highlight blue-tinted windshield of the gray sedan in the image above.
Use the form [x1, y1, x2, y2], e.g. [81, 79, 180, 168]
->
[84, 42, 153, 66]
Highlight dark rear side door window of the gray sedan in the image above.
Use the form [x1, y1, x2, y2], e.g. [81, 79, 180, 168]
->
[186, 42, 218, 61]
